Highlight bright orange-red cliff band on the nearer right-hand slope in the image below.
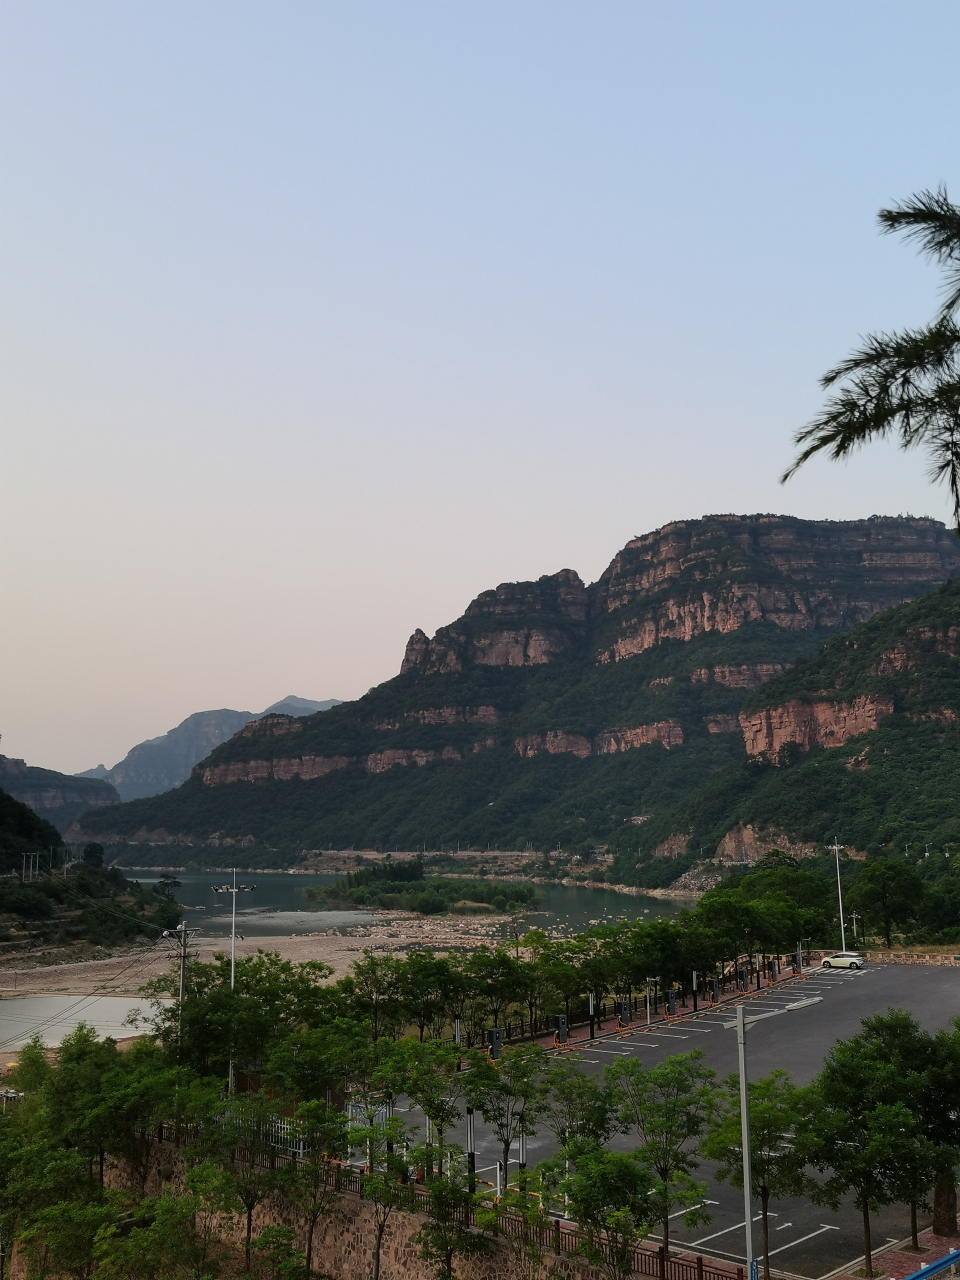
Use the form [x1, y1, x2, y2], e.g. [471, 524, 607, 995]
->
[740, 694, 893, 756]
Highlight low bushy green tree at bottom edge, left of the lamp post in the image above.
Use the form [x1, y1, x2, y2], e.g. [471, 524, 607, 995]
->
[554, 1143, 666, 1280]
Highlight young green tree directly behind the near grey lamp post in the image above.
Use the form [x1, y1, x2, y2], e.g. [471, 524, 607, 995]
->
[700, 1070, 809, 1280]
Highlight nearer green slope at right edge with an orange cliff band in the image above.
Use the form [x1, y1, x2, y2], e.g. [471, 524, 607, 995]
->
[634, 581, 960, 865]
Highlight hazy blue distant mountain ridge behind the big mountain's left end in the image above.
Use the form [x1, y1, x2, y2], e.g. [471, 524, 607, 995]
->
[76, 694, 339, 800]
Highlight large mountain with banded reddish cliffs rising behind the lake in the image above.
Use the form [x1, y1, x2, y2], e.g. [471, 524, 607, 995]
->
[69, 516, 960, 868]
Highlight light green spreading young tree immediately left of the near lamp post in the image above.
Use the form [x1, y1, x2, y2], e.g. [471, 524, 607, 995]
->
[604, 1050, 717, 1263]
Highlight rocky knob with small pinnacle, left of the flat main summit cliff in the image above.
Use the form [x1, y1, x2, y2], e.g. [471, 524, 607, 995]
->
[401, 570, 588, 676]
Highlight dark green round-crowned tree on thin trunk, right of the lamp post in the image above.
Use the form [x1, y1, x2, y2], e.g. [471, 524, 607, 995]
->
[796, 1085, 931, 1277]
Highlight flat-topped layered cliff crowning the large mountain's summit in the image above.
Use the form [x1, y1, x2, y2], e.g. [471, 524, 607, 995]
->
[591, 516, 960, 662]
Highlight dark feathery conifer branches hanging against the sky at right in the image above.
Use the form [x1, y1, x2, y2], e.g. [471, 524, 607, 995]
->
[782, 187, 960, 529]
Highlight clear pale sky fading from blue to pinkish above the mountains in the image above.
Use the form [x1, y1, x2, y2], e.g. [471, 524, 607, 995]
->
[0, 0, 960, 772]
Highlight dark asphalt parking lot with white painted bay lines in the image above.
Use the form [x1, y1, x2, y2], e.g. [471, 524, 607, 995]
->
[455, 965, 960, 1280]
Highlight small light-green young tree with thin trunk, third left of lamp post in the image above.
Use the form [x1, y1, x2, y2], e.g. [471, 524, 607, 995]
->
[465, 1044, 549, 1184]
